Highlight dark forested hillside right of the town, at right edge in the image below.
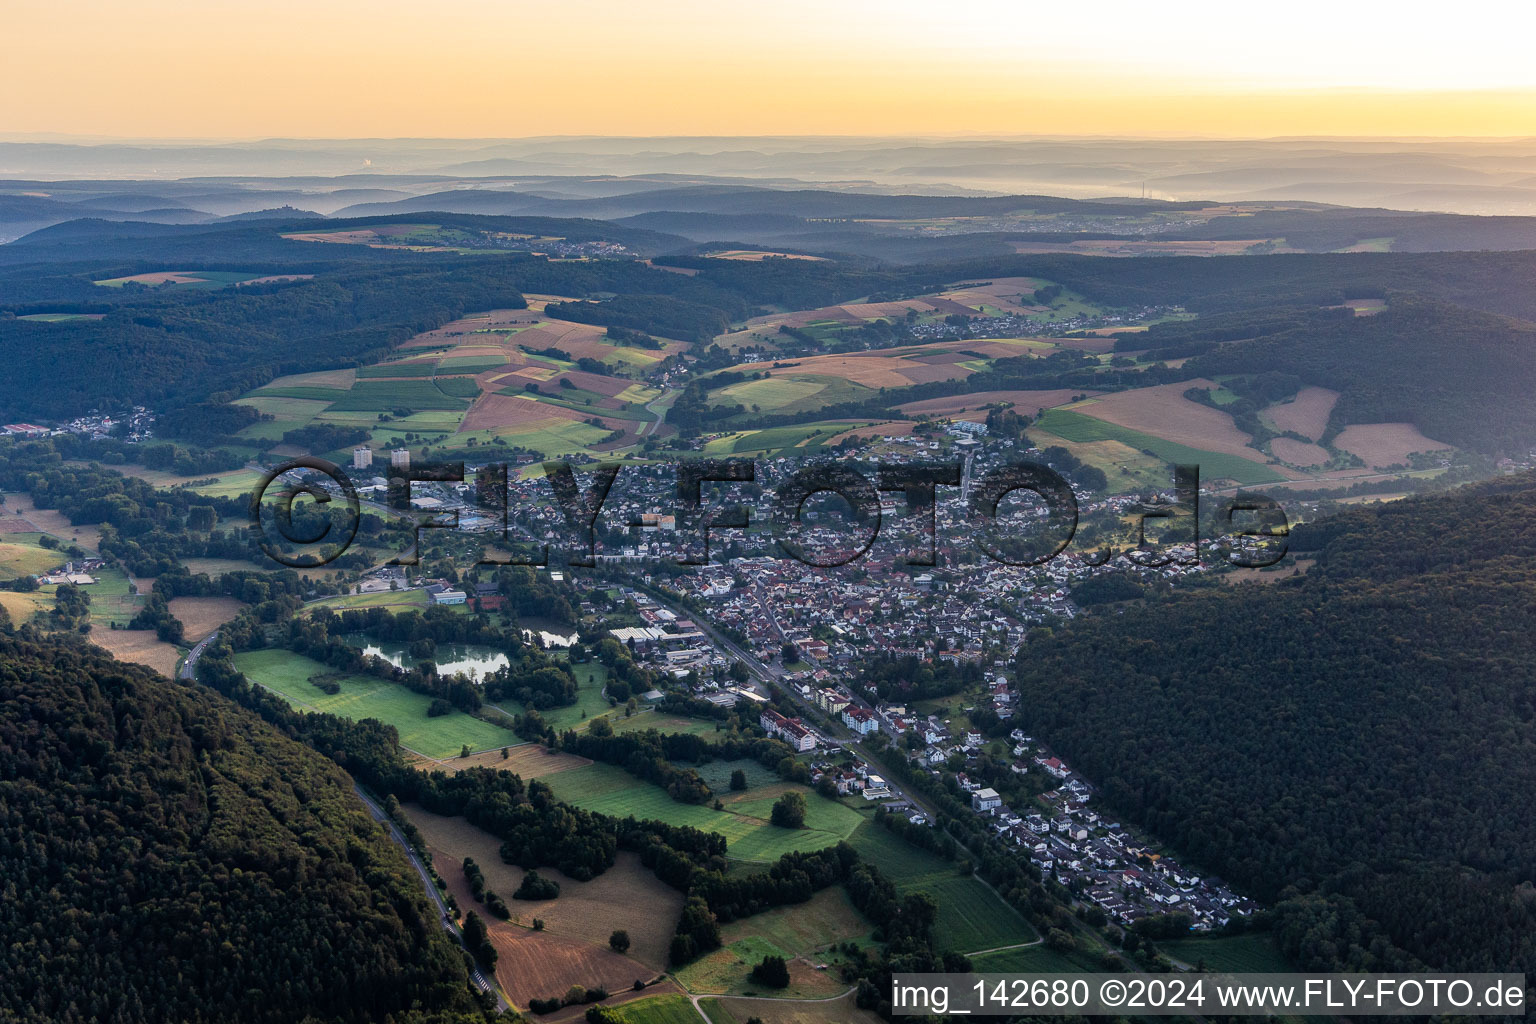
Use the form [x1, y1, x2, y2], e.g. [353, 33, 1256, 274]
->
[1018, 476, 1536, 972]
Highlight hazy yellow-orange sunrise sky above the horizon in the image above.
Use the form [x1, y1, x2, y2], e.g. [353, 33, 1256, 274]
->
[12, 0, 1536, 138]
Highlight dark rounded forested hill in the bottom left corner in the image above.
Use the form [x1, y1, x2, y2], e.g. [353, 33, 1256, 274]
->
[0, 636, 481, 1024]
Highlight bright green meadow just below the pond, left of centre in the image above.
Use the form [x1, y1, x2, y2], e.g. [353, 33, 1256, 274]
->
[235, 649, 518, 760]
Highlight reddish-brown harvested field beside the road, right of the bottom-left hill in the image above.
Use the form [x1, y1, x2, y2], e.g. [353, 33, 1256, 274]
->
[406, 804, 684, 976]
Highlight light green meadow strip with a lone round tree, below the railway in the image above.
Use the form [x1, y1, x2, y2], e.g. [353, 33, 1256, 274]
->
[547, 765, 863, 861]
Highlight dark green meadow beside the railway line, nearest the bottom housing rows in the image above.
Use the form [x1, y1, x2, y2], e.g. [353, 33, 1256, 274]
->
[849, 820, 1040, 952]
